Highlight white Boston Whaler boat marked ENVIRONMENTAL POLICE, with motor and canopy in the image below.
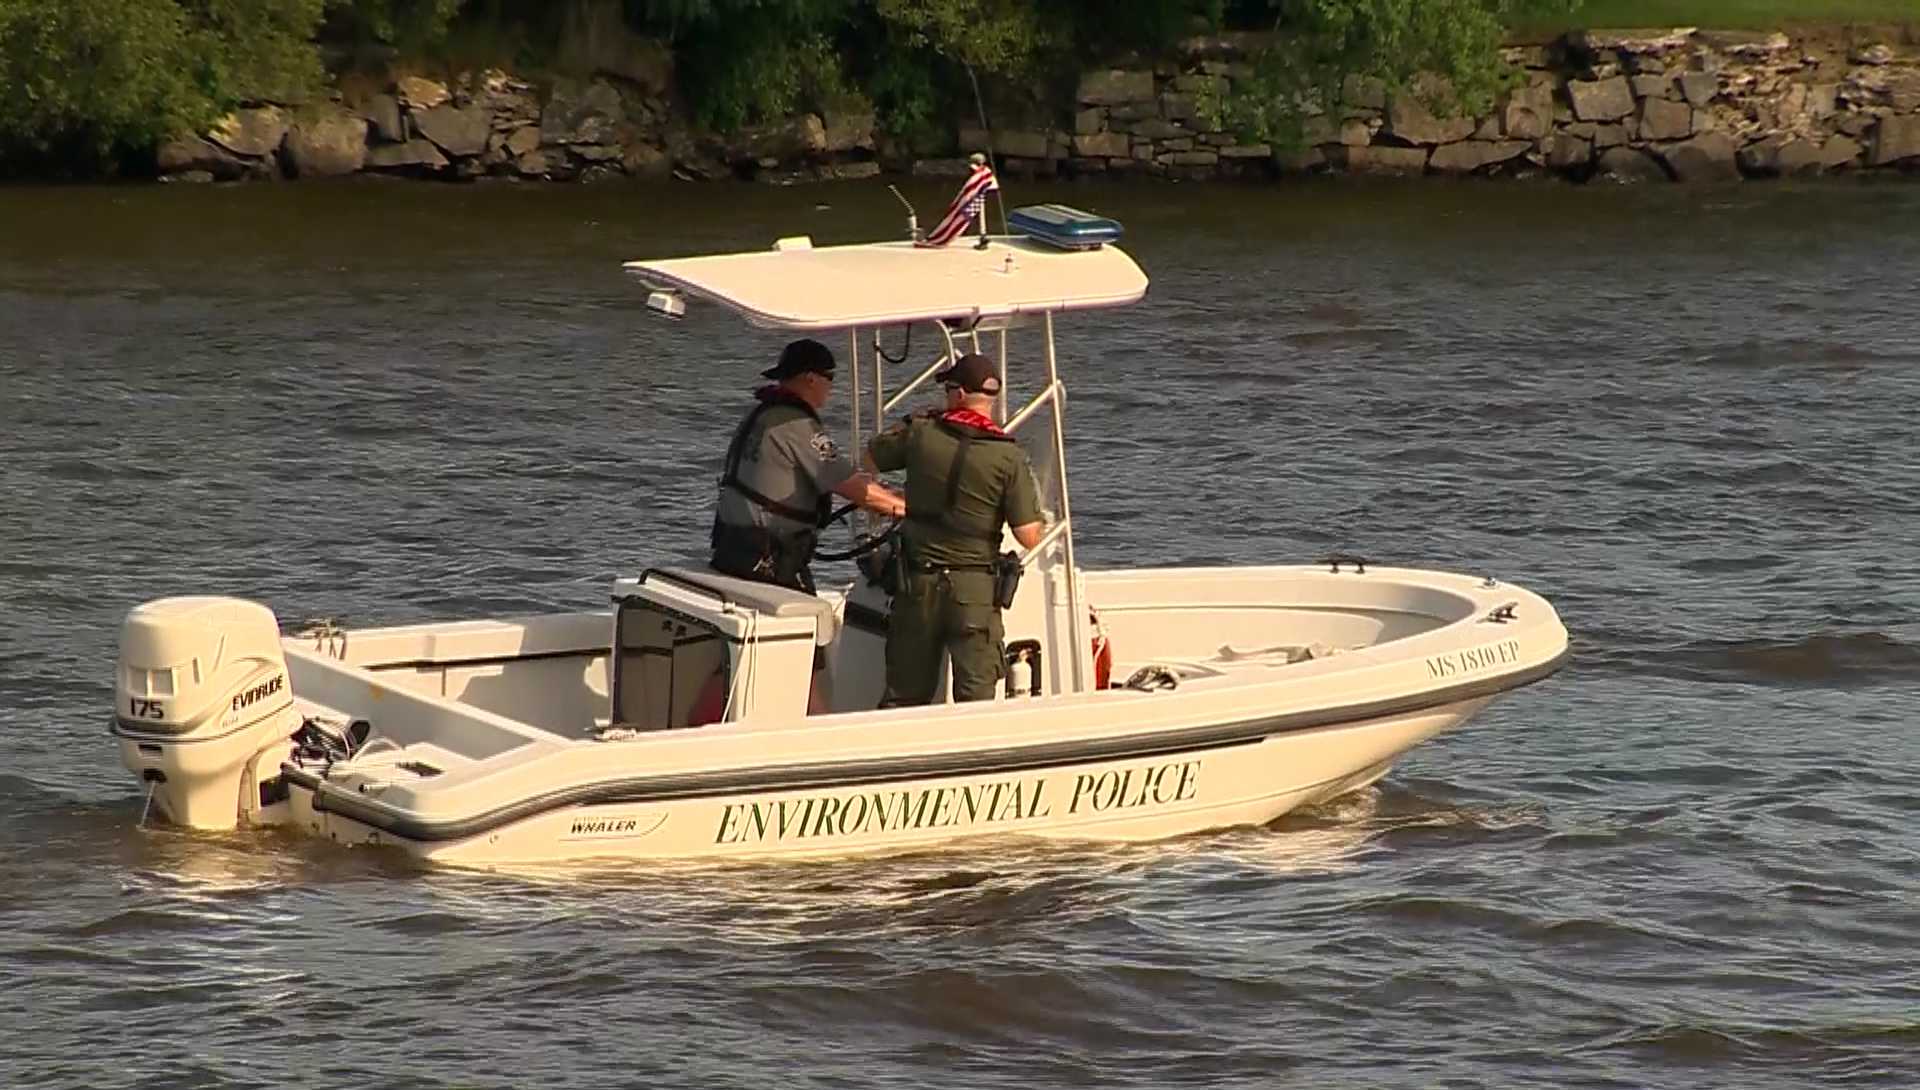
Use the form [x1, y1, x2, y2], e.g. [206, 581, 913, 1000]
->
[113, 187, 1567, 864]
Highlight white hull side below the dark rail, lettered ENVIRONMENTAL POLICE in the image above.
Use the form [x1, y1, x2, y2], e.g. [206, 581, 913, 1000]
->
[290, 699, 1486, 865]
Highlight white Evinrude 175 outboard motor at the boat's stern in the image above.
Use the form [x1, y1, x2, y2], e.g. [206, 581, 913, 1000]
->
[113, 597, 301, 829]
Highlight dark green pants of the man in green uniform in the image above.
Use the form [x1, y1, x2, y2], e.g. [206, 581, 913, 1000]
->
[879, 570, 1006, 708]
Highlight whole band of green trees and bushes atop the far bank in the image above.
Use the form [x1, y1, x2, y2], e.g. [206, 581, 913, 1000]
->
[0, 0, 1681, 167]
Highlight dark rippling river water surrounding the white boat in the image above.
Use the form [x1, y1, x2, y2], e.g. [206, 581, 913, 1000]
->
[0, 174, 1920, 1090]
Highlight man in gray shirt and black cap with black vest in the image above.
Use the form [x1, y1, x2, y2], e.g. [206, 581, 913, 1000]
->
[710, 340, 906, 593]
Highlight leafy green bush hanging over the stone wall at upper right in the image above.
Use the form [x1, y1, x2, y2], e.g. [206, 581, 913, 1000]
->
[1225, 0, 1578, 144]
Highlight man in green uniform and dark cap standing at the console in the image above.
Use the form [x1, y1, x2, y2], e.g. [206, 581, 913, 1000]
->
[868, 355, 1046, 708]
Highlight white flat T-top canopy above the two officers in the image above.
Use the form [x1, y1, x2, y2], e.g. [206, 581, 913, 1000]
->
[626, 238, 1146, 330]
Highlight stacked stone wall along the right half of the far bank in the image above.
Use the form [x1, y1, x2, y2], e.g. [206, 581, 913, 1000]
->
[956, 29, 1920, 182]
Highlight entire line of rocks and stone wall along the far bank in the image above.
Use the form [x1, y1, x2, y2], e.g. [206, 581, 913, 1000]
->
[157, 29, 1920, 182]
